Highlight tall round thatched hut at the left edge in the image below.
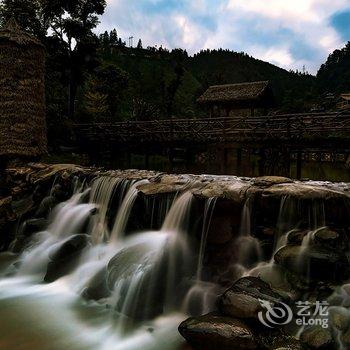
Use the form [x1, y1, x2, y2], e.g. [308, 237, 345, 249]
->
[0, 19, 47, 159]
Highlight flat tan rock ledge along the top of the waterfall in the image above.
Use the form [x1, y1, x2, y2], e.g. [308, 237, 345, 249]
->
[8, 163, 350, 202]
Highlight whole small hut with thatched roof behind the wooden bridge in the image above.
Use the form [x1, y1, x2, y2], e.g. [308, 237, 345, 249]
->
[197, 81, 274, 117]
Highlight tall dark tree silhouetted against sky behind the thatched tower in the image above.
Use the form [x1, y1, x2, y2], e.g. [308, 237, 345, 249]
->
[0, 0, 106, 117]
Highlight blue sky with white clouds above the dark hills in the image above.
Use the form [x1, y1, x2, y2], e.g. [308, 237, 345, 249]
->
[98, 0, 350, 74]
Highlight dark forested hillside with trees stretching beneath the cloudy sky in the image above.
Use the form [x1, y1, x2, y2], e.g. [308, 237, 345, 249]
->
[0, 0, 350, 149]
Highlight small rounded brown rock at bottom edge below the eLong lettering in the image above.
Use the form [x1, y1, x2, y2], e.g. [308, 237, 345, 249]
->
[300, 326, 336, 350]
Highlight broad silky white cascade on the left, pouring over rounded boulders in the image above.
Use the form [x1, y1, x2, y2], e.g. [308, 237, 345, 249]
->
[0, 177, 200, 350]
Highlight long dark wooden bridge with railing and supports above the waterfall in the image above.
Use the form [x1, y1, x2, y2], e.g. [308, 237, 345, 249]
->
[75, 112, 350, 178]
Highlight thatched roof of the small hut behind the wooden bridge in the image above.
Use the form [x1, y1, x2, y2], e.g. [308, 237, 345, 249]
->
[197, 81, 270, 103]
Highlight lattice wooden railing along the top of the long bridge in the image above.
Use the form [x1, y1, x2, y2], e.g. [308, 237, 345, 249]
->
[75, 112, 350, 142]
